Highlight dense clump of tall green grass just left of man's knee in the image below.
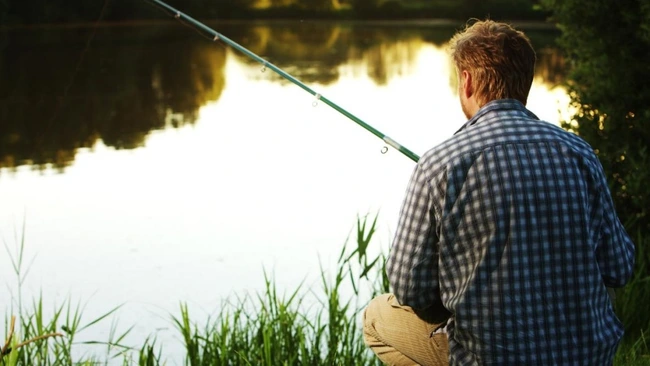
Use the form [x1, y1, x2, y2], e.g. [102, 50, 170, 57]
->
[174, 216, 384, 366]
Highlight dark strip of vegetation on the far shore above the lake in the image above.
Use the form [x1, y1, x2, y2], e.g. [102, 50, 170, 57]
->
[0, 0, 549, 26]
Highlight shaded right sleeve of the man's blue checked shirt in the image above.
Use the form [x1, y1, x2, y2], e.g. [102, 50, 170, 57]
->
[596, 164, 634, 287]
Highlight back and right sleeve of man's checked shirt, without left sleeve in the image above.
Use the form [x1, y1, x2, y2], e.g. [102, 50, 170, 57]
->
[404, 100, 633, 365]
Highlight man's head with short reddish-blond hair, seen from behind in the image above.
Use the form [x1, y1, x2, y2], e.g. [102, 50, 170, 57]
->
[449, 20, 536, 118]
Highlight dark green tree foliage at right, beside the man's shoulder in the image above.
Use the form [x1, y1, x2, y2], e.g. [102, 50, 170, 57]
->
[542, 0, 650, 335]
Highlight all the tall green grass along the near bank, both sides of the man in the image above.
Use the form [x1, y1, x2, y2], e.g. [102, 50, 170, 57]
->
[5, 216, 650, 366]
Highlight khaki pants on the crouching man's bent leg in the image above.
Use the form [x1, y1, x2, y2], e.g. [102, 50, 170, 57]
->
[363, 294, 449, 366]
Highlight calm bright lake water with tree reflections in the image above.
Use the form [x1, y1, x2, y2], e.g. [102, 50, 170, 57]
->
[0, 21, 568, 360]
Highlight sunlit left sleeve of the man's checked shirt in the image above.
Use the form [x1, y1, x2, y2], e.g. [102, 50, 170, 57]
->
[386, 165, 440, 309]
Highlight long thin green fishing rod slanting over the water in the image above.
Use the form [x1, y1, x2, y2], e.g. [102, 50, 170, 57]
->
[147, 0, 420, 162]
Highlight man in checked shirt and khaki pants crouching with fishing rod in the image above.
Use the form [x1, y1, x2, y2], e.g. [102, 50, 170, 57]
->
[364, 20, 634, 365]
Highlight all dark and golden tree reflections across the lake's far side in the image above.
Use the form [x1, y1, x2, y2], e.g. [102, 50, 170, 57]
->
[0, 22, 564, 171]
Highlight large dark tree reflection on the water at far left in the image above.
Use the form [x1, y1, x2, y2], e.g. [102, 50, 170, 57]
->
[0, 27, 226, 170]
